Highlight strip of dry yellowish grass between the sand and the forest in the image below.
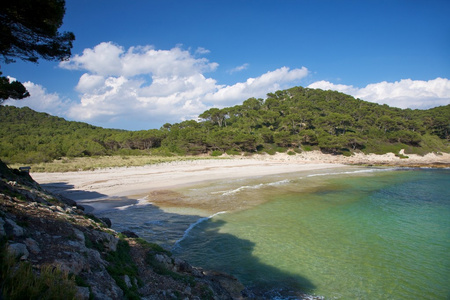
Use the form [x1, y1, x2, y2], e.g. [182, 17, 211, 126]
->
[9, 155, 229, 172]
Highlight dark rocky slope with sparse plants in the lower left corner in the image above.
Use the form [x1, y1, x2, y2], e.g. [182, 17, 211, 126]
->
[0, 162, 245, 299]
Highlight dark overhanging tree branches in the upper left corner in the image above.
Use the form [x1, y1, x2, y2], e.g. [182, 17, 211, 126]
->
[0, 0, 75, 103]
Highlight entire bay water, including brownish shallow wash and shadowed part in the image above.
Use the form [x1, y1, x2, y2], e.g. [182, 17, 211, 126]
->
[94, 166, 450, 299]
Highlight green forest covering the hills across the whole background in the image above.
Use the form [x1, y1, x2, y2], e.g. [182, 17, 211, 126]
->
[0, 87, 450, 163]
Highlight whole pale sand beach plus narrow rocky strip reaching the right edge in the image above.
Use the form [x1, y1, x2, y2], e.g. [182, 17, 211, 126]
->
[31, 151, 450, 200]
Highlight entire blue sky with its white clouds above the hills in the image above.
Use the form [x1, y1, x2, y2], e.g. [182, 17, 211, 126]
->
[1, 0, 450, 130]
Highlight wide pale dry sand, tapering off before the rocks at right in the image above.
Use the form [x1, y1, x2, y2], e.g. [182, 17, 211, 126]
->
[31, 158, 345, 201]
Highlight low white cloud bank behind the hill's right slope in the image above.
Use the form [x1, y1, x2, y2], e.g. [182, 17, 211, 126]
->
[308, 78, 450, 109]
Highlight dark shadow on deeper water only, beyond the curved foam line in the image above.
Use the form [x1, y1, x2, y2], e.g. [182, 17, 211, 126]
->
[174, 220, 315, 299]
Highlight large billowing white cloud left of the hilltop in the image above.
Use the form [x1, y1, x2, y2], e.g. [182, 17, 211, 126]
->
[56, 42, 308, 127]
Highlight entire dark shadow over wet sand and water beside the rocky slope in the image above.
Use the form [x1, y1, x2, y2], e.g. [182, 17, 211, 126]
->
[41, 182, 315, 299]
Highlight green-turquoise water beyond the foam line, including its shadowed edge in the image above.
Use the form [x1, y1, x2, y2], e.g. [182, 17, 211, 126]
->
[170, 170, 450, 299]
